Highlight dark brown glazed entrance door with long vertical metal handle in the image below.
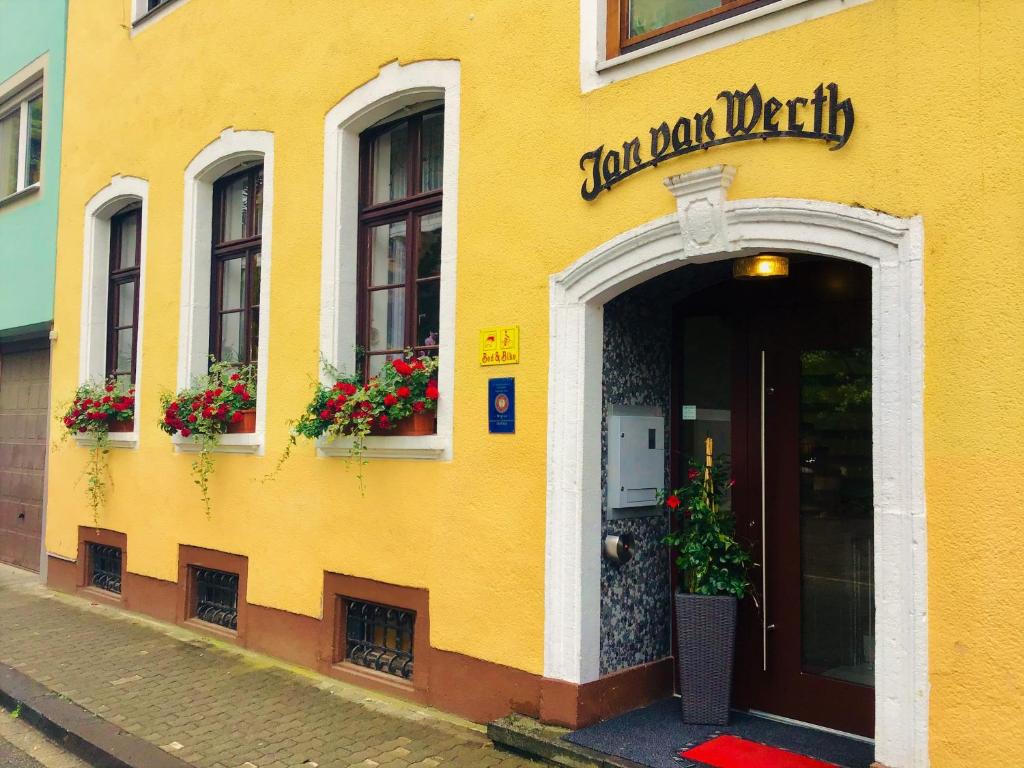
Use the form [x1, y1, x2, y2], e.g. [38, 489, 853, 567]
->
[677, 261, 874, 736]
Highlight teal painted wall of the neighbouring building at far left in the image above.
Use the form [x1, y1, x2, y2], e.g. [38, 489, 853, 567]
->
[0, 0, 68, 337]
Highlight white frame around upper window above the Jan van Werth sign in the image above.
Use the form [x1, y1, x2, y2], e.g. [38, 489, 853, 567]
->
[580, 0, 871, 93]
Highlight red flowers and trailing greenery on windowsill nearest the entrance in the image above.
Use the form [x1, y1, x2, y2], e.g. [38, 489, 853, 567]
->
[268, 350, 440, 486]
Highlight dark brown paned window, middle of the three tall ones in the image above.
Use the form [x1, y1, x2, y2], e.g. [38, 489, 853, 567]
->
[210, 165, 263, 365]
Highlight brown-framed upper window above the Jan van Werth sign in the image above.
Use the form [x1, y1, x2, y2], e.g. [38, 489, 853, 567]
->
[606, 0, 778, 58]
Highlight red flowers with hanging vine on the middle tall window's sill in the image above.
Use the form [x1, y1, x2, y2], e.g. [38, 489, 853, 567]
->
[160, 362, 256, 515]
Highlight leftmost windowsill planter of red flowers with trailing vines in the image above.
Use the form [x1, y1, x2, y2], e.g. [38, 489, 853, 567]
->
[60, 379, 135, 524]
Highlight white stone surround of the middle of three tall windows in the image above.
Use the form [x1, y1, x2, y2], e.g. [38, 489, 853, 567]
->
[177, 128, 273, 456]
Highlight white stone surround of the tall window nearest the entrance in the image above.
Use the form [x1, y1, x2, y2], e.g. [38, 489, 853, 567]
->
[318, 60, 461, 460]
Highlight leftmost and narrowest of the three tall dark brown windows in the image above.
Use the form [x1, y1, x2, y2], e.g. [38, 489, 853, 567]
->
[106, 207, 142, 386]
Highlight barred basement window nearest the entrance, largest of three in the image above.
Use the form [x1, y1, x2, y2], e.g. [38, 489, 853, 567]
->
[344, 598, 416, 680]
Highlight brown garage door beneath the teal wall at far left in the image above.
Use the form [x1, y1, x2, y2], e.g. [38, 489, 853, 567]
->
[0, 344, 50, 571]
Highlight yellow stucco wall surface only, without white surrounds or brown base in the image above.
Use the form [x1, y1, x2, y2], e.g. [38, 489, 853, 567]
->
[47, 0, 1024, 766]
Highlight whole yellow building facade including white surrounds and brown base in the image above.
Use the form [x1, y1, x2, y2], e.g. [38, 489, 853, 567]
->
[45, 0, 1024, 768]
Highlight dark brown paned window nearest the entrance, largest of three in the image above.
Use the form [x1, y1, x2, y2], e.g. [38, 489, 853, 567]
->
[357, 106, 444, 378]
